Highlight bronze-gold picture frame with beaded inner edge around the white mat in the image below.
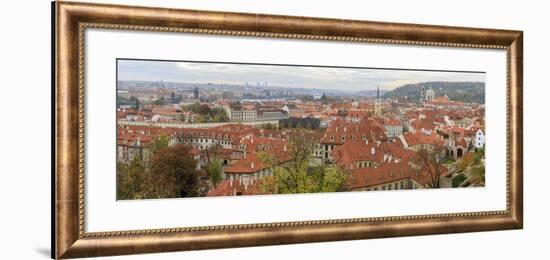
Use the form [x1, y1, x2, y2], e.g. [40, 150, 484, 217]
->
[52, 2, 523, 258]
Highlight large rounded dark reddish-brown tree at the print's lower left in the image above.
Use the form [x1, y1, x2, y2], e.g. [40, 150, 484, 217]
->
[149, 144, 203, 198]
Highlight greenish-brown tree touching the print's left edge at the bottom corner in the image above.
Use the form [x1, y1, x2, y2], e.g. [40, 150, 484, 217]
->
[117, 155, 145, 200]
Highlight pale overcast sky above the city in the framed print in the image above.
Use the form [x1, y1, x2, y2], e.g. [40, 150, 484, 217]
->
[118, 60, 485, 91]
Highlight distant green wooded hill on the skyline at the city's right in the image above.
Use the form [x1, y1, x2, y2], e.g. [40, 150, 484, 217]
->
[382, 81, 485, 103]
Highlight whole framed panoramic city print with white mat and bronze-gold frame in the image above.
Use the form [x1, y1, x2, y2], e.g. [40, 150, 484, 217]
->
[52, 2, 523, 258]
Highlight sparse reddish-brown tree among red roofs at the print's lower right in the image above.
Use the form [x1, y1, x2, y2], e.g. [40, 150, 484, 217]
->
[413, 145, 449, 188]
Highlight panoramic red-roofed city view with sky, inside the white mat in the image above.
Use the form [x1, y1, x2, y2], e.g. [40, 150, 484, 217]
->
[116, 59, 486, 200]
